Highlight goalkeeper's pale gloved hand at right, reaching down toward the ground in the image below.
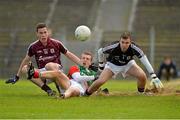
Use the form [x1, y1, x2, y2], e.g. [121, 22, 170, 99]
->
[150, 73, 164, 88]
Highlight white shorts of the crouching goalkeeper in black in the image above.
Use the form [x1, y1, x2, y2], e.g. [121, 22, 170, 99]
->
[105, 60, 136, 77]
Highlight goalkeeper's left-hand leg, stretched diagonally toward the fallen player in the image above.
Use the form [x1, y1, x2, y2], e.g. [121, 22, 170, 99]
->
[87, 68, 114, 94]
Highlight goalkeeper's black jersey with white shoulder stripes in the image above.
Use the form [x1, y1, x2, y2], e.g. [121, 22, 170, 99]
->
[102, 42, 144, 66]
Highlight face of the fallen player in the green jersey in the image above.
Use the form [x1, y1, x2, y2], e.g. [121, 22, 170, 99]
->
[81, 54, 92, 68]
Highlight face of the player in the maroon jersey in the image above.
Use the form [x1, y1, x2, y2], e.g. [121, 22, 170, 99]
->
[37, 27, 49, 43]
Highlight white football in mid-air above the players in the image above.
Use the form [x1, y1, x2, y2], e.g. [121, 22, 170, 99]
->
[75, 25, 91, 41]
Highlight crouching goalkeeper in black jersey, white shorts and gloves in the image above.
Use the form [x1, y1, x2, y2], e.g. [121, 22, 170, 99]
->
[86, 32, 163, 95]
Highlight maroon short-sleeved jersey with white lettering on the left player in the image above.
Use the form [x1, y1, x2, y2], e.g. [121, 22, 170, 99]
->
[27, 38, 67, 68]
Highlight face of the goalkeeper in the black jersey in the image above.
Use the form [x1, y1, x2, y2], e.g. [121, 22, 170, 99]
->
[120, 38, 131, 52]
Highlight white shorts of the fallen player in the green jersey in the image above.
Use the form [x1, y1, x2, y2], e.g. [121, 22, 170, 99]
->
[59, 79, 85, 96]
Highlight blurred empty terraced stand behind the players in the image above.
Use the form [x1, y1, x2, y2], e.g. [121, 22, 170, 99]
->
[0, 0, 180, 78]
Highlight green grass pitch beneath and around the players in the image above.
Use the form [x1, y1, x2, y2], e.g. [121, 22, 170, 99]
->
[0, 80, 180, 119]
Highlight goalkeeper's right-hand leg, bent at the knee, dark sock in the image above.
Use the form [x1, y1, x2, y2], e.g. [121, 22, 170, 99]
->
[126, 63, 147, 92]
